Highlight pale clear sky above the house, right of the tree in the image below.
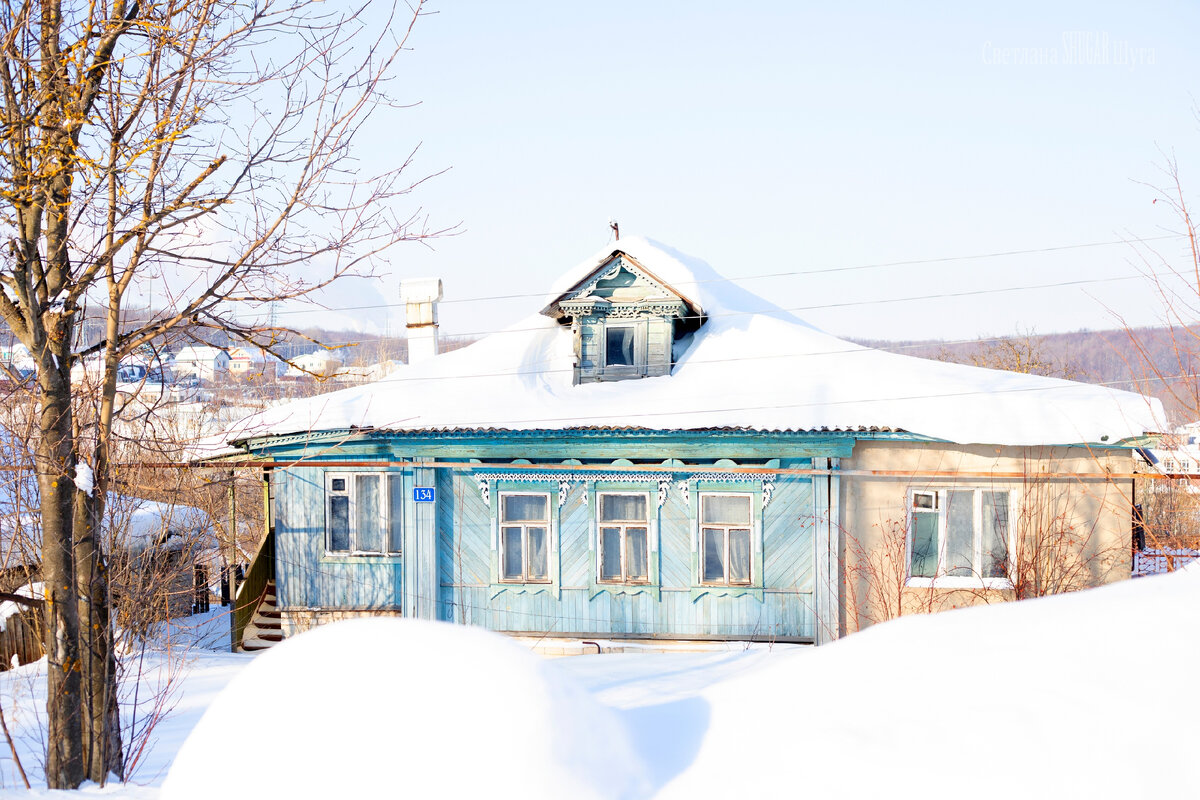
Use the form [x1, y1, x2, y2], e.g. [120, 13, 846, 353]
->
[304, 0, 1200, 339]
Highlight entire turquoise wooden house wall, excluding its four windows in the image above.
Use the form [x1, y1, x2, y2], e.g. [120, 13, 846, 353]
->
[260, 431, 852, 640]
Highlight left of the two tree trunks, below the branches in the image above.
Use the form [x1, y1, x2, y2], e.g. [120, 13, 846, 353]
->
[36, 367, 83, 789]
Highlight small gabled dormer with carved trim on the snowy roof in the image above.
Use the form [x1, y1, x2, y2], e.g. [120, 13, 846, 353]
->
[542, 249, 703, 384]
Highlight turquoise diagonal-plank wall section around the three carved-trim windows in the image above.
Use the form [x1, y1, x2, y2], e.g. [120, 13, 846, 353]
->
[438, 470, 815, 639]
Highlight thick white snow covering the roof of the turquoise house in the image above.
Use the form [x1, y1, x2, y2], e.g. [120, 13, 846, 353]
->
[228, 237, 1163, 445]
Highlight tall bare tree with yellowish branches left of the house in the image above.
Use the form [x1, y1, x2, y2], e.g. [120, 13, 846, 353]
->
[0, 0, 444, 788]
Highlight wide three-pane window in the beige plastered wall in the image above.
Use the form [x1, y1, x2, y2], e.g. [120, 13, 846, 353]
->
[908, 489, 1009, 583]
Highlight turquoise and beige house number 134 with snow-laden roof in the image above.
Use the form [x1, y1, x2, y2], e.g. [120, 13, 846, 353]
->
[216, 239, 1160, 648]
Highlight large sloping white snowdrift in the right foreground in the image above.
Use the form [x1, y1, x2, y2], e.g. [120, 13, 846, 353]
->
[658, 565, 1200, 800]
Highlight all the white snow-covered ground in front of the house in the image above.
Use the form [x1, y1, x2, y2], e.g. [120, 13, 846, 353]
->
[0, 567, 1200, 800]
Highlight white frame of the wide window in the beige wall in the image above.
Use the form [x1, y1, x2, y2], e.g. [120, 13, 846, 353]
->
[904, 486, 1016, 589]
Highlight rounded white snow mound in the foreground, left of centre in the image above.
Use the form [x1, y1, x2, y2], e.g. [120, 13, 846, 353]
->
[162, 618, 647, 800]
